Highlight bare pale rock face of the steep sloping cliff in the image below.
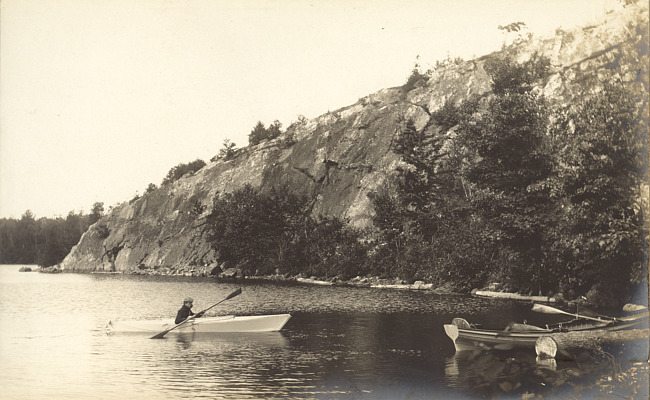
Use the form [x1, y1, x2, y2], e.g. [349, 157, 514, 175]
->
[61, 1, 648, 275]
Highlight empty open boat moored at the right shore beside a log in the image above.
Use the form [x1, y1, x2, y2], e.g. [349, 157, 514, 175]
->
[444, 312, 648, 351]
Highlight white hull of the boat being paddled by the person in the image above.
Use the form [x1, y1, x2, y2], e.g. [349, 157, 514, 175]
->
[106, 314, 291, 333]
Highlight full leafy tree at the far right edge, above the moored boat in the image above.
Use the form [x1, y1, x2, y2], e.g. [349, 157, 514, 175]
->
[553, 82, 648, 297]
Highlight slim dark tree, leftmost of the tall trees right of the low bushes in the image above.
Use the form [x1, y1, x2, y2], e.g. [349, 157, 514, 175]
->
[371, 116, 449, 280]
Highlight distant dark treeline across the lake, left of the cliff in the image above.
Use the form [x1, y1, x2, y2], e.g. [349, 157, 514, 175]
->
[0, 202, 105, 267]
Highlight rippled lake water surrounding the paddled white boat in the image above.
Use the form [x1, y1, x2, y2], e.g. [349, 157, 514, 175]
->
[0, 265, 648, 399]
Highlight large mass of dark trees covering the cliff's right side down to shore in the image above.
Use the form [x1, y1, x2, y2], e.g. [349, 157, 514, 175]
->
[372, 50, 648, 304]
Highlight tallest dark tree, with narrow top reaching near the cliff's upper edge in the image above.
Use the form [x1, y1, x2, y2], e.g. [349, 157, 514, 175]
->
[457, 56, 553, 291]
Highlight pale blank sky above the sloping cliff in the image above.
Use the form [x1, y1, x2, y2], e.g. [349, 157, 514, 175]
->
[0, 0, 620, 218]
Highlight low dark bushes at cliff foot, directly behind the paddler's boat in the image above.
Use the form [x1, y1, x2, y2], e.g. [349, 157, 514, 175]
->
[207, 185, 366, 278]
